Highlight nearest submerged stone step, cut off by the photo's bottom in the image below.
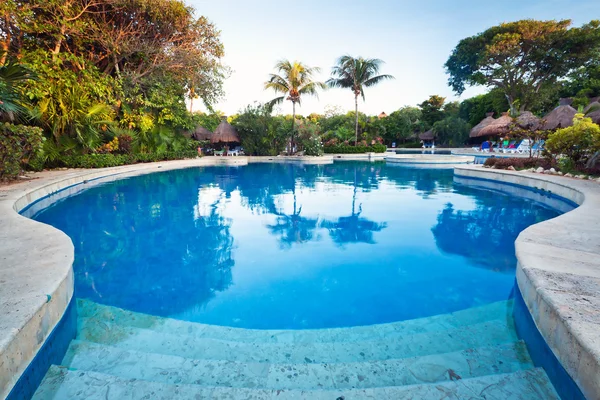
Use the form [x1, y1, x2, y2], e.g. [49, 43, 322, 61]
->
[33, 366, 559, 400]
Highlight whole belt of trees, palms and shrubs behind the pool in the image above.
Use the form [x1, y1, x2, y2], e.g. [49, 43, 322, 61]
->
[0, 7, 600, 178]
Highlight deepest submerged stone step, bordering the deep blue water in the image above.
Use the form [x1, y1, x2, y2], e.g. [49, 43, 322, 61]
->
[77, 299, 513, 343]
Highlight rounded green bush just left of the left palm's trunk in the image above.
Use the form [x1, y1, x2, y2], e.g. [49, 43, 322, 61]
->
[231, 105, 289, 156]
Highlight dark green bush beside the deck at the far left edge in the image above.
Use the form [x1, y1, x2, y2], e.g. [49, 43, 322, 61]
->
[0, 123, 44, 180]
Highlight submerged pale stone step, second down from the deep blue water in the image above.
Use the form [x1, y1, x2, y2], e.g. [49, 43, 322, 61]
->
[77, 320, 519, 363]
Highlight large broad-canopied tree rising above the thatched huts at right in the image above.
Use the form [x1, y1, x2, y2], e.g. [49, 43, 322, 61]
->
[445, 20, 600, 114]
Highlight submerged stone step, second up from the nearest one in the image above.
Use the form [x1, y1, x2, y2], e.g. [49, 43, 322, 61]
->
[62, 341, 534, 390]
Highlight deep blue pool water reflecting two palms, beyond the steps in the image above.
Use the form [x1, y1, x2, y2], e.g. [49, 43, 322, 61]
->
[32, 162, 559, 329]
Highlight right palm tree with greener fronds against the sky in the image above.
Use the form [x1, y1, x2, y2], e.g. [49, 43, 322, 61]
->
[325, 55, 394, 146]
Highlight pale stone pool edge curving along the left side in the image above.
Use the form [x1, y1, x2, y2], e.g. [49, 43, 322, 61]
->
[0, 157, 274, 399]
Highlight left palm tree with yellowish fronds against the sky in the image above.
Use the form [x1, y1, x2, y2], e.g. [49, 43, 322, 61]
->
[265, 60, 327, 150]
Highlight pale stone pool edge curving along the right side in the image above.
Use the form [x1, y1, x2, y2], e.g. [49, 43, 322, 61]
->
[454, 166, 600, 399]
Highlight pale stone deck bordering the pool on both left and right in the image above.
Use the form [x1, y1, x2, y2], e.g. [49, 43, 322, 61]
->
[0, 157, 600, 399]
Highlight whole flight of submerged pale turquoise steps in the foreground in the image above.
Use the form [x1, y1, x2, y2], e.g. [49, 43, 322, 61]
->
[34, 300, 558, 400]
